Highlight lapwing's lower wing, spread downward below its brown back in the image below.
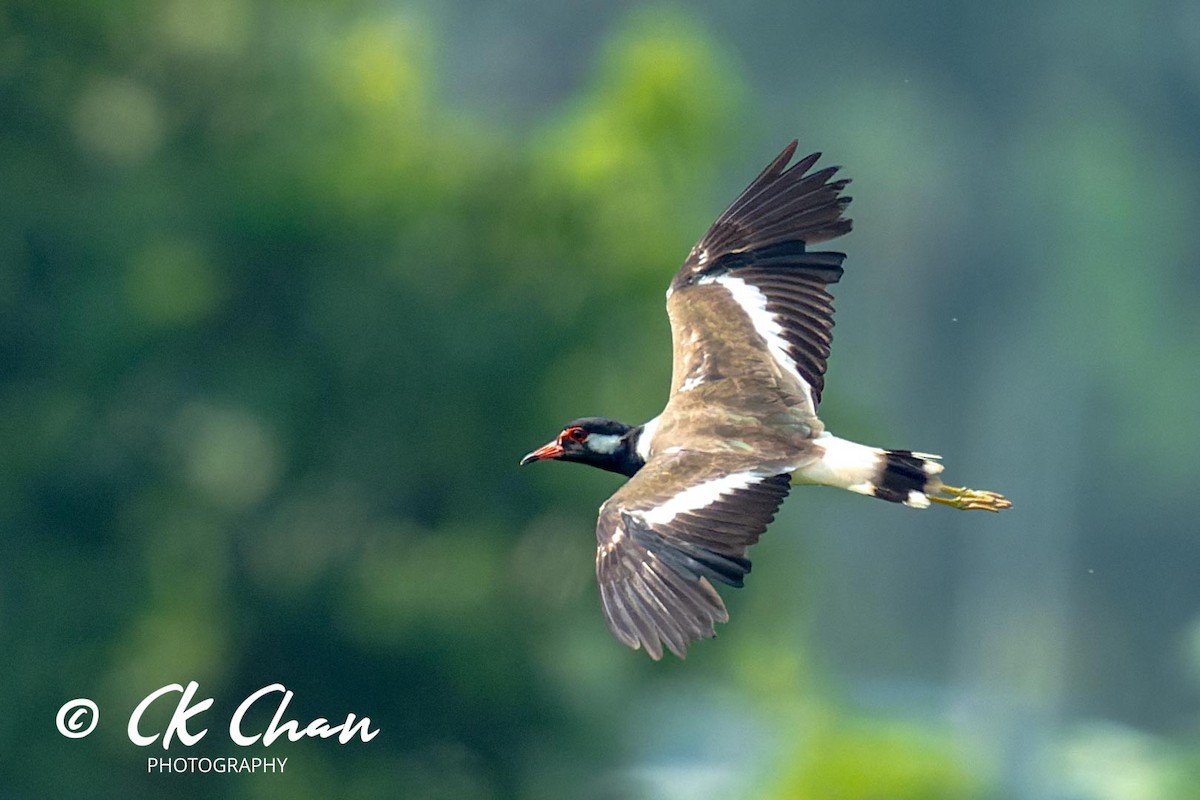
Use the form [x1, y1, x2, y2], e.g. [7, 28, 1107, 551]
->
[596, 451, 790, 660]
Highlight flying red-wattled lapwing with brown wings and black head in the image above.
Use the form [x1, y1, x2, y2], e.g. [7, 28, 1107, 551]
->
[521, 142, 1012, 658]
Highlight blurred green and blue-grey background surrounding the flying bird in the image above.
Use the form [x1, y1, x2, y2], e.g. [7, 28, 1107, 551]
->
[0, 0, 1200, 800]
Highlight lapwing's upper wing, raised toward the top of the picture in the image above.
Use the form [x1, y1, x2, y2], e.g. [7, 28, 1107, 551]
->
[667, 142, 852, 415]
